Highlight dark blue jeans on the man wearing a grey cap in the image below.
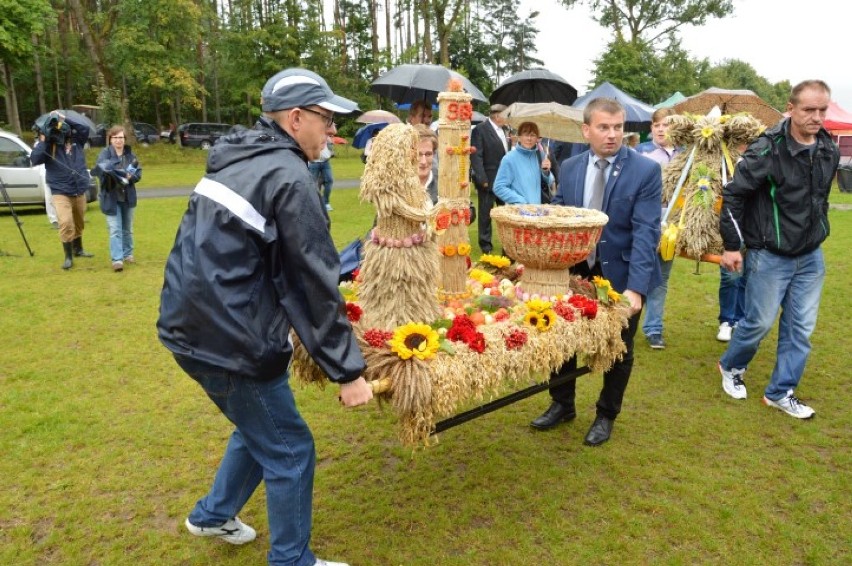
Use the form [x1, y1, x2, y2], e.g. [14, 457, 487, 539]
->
[175, 356, 316, 566]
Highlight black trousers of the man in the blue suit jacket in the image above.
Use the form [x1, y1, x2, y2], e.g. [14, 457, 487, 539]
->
[550, 262, 644, 420]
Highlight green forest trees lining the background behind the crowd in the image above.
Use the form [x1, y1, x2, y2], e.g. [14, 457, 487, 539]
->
[0, 0, 790, 140]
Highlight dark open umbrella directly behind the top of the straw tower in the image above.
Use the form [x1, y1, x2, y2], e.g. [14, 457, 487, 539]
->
[370, 64, 488, 104]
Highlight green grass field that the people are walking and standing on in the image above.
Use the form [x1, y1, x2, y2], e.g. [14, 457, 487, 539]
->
[0, 175, 852, 566]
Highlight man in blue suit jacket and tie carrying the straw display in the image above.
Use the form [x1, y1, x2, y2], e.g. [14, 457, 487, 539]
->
[531, 98, 663, 446]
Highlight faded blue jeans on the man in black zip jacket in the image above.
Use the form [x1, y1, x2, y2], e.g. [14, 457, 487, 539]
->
[720, 249, 825, 401]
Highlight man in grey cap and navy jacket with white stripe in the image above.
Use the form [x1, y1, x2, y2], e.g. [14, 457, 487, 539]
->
[157, 69, 372, 565]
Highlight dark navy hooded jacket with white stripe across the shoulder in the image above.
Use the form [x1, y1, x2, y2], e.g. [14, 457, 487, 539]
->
[157, 118, 364, 383]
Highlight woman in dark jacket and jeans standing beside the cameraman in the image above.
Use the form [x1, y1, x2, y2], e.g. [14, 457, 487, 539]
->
[92, 126, 142, 271]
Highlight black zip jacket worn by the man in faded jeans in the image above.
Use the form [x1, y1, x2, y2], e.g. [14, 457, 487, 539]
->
[720, 118, 840, 256]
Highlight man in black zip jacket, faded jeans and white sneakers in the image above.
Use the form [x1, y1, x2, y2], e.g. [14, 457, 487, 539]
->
[719, 80, 840, 419]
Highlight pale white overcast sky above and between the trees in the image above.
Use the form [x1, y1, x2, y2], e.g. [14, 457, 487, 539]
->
[518, 0, 852, 112]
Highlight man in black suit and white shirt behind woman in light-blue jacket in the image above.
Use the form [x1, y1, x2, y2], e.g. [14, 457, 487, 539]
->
[470, 104, 511, 254]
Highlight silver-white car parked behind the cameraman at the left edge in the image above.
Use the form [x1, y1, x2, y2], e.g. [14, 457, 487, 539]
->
[0, 130, 98, 207]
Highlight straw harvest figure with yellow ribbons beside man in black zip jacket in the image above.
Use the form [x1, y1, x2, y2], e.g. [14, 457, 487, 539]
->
[663, 114, 765, 259]
